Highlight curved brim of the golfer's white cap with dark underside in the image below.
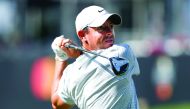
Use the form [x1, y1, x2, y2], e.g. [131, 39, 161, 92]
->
[88, 14, 121, 27]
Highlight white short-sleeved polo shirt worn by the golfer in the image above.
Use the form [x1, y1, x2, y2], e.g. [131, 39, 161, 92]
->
[58, 44, 140, 109]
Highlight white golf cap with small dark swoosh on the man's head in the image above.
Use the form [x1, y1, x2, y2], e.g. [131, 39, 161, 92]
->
[75, 6, 121, 33]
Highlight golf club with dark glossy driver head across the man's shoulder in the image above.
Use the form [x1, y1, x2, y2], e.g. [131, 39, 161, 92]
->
[65, 43, 129, 75]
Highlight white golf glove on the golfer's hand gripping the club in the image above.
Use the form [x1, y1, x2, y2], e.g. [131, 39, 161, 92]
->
[51, 35, 69, 61]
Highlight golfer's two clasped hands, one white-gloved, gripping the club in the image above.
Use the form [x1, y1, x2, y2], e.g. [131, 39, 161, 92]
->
[51, 35, 81, 61]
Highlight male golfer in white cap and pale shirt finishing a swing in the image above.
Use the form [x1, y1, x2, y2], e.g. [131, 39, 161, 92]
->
[51, 6, 140, 109]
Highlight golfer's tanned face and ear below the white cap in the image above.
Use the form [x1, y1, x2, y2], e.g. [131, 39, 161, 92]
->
[83, 21, 114, 50]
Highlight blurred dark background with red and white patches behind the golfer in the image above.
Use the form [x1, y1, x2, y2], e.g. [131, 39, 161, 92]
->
[0, 0, 190, 109]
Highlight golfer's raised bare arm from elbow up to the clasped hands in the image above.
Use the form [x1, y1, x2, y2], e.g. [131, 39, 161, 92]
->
[51, 36, 81, 109]
